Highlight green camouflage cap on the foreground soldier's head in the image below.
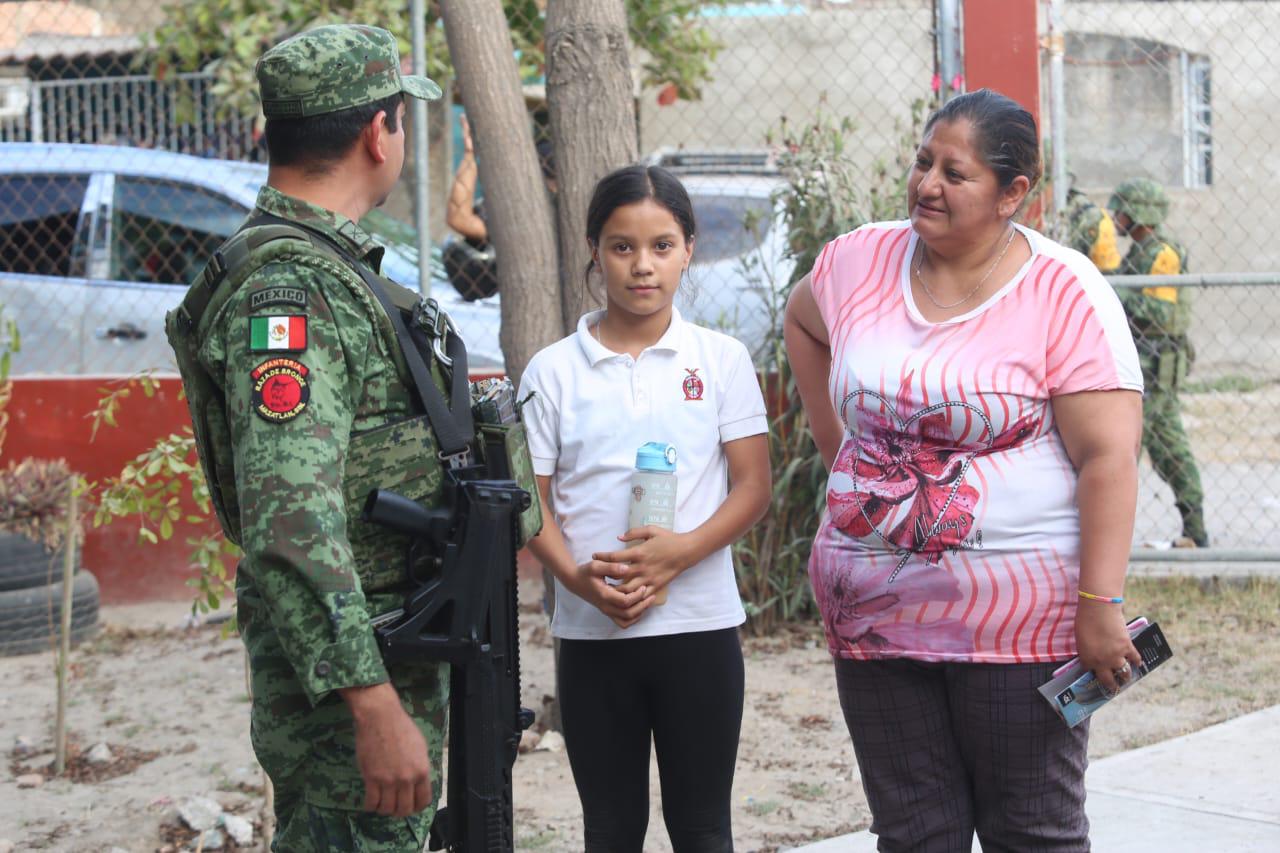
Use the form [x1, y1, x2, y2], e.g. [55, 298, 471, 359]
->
[256, 24, 440, 118]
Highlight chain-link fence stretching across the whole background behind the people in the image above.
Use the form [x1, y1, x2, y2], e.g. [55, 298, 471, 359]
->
[0, 0, 1280, 548]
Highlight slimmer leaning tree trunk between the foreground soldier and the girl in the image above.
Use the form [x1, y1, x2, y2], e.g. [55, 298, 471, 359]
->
[440, 0, 563, 383]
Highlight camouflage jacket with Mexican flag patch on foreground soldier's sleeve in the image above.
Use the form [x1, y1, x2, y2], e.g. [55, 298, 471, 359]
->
[198, 187, 412, 704]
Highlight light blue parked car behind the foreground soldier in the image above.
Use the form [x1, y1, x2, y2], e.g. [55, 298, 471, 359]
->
[0, 143, 502, 375]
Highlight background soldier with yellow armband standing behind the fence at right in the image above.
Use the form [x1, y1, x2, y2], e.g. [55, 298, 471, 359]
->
[1107, 178, 1208, 547]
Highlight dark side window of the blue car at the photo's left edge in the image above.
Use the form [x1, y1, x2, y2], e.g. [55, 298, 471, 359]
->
[0, 174, 88, 275]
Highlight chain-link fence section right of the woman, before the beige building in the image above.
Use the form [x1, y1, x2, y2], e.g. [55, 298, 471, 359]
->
[1046, 0, 1280, 550]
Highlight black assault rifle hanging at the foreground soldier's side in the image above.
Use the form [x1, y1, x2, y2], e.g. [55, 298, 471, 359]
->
[364, 466, 534, 853]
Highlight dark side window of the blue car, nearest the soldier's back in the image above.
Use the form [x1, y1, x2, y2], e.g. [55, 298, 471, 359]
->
[109, 175, 248, 284]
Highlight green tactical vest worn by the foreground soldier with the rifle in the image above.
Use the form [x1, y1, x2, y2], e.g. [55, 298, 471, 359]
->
[165, 216, 472, 592]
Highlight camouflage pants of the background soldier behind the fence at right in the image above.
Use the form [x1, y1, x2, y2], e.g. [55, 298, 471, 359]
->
[1138, 339, 1207, 544]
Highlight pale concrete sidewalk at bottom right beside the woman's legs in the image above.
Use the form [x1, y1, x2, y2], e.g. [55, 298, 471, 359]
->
[795, 706, 1280, 853]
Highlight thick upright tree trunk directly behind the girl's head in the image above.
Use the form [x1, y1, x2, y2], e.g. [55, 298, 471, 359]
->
[547, 0, 636, 334]
